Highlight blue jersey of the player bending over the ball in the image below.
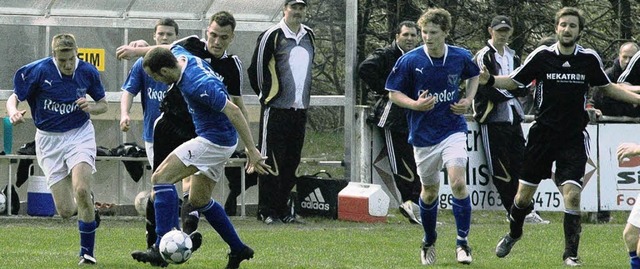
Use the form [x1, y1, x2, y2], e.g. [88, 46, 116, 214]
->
[171, 46, 238, 147]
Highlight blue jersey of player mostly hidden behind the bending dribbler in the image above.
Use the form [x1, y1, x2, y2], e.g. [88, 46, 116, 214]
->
[122, 58, 168, 142]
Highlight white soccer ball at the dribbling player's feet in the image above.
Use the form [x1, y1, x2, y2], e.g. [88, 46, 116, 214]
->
[158, 230, 193, 264]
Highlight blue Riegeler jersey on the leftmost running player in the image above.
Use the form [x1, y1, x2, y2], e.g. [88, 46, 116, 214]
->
[13, 57, 105, 132]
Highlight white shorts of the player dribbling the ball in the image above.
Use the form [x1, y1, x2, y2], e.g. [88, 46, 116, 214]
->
[173, 137, 237, 182]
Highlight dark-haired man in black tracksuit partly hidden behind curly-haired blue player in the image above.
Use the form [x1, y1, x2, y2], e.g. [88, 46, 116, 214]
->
[358, 21, 422, 223]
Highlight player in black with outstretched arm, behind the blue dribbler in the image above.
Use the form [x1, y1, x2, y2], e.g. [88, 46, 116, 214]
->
[117, 11, 253, 268]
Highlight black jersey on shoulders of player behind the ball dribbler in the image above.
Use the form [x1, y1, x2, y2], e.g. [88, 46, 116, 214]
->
[174, 35, 243, 96]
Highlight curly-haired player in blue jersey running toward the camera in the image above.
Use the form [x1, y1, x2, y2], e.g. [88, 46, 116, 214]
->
[385, 8, 479, 265]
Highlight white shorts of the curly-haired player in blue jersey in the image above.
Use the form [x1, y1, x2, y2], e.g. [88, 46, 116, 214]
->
[413, 133, 467, 185]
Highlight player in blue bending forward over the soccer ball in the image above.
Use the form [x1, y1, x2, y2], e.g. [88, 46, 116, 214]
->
[132, 45, 270, 268]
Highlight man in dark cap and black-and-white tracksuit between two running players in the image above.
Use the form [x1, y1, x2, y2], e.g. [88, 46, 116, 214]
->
[474, 16, 548, 223]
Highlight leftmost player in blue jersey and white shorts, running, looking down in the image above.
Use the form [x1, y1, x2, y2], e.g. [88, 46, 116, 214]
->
[6, 34, 107, 265]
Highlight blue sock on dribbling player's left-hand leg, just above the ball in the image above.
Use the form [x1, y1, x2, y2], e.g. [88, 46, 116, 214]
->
[153, 184, 180, 246]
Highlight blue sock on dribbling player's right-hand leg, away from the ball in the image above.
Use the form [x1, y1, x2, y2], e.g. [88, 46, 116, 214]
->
[198, 199, 245, 253]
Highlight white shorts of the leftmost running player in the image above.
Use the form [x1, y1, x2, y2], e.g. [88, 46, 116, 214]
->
[36, 120, 96, 187]
